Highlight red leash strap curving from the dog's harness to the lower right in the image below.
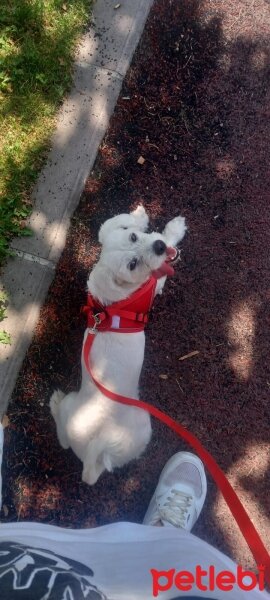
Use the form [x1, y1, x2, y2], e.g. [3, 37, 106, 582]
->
[83, 332, 270, 585]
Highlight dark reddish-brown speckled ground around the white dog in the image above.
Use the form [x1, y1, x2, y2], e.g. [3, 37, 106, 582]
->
[2, 0, 270, 576]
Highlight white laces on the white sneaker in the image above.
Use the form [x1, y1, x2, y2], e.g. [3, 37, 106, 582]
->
[159, 489, 193, 528]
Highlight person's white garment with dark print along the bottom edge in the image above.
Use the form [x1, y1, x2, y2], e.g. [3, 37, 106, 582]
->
[0, 522, 270, 600]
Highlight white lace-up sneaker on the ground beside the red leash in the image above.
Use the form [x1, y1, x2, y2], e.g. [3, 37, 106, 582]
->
[143, 452, 207, 531]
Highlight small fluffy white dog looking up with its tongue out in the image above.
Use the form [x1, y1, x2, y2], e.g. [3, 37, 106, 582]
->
[50, 206, 186, 485]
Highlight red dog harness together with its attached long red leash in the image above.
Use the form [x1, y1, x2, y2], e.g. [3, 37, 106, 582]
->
[83, 284, 270, 585]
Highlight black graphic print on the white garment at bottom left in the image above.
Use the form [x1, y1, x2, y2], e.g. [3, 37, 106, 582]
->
[0, 542, 107, 600]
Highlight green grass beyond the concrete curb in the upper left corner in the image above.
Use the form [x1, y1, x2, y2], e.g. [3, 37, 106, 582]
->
[0, 0, 91, 264]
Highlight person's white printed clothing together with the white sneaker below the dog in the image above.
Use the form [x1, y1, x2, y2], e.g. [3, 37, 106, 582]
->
[0, 453, 270, 600]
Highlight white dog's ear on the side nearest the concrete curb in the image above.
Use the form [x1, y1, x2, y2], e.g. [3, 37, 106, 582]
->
[98, 204, 149, 244]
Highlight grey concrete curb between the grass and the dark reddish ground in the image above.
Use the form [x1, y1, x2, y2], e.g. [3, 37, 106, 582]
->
[0, 0, 153, 416]
